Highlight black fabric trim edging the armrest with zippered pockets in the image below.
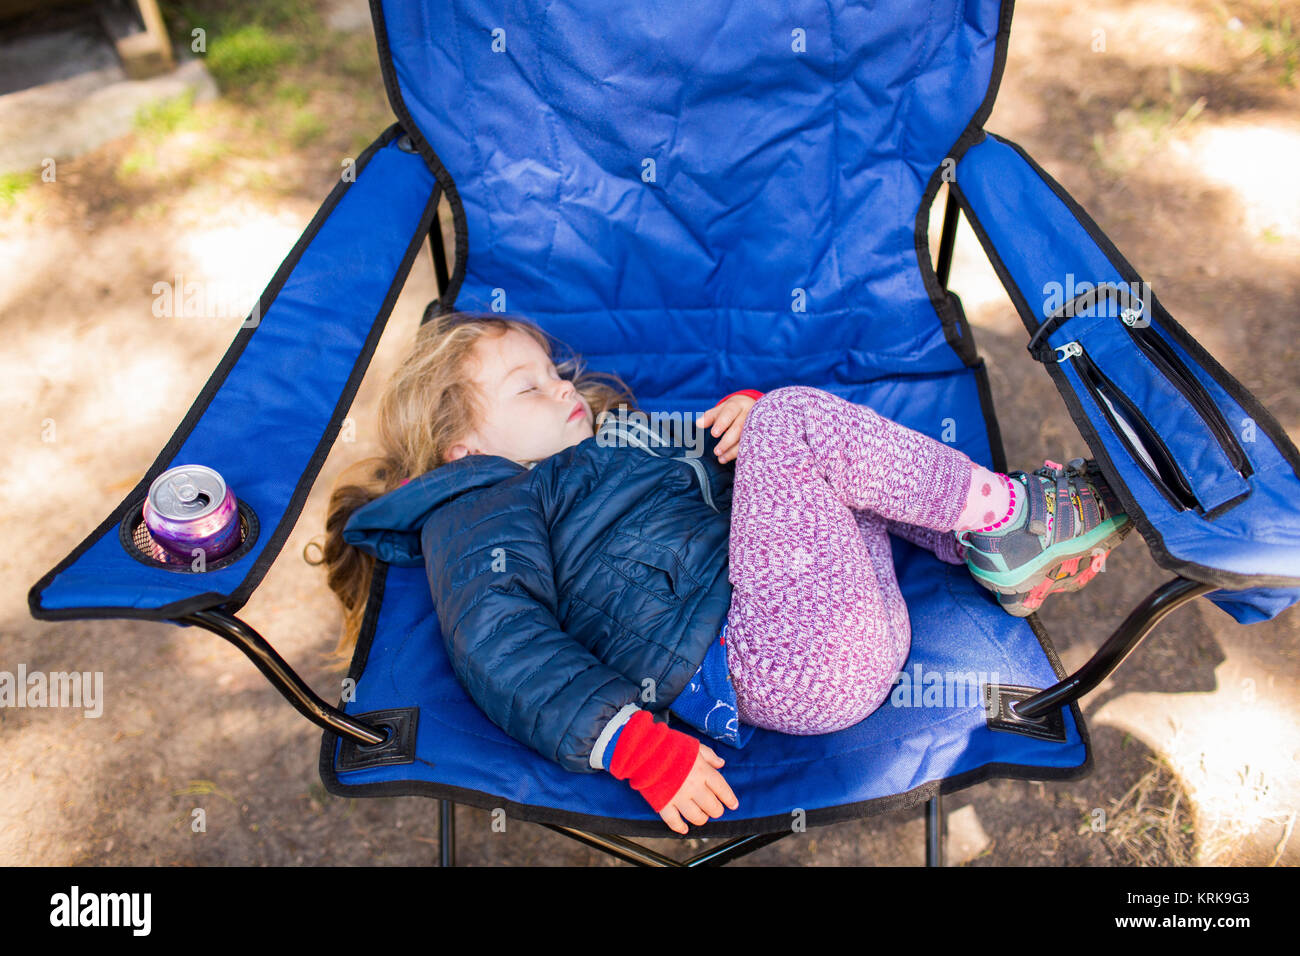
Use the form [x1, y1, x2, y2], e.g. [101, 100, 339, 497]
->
[949, 133, 1300, 591]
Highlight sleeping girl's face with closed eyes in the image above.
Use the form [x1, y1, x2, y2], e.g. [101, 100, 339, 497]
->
[449, 329, 595, 464]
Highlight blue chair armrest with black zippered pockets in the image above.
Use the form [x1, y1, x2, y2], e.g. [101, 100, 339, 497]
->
[952, 134, 1300, 623]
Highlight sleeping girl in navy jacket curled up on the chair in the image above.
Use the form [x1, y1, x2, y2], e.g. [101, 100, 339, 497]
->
[312, 313, 1131, 834]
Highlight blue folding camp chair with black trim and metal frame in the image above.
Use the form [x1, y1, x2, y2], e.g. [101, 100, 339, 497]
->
[30, 0, 1300, 865]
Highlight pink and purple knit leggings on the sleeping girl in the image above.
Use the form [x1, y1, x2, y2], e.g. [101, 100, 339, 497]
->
[727, 385, 971, 734]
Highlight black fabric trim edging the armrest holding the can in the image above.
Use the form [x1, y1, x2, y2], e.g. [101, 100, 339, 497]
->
[27, 124, 438, 620]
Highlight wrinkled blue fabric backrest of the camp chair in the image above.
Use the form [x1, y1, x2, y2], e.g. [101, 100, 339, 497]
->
[372, 0, 1011, 395]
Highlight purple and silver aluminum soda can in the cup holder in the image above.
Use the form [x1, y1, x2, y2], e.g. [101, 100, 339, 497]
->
[144, 464, 239, 564]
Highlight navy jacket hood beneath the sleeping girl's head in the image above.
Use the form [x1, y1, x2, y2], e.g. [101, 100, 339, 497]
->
[343, 455, 528, 567]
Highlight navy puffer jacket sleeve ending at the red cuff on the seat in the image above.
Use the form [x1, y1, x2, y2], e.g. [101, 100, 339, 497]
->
[421, 484, 641, 773]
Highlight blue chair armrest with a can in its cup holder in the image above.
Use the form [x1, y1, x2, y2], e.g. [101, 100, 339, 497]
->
[27, 125, 439, 620]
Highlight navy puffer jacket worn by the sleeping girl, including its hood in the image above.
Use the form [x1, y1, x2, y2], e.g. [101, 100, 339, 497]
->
[343, 412, 735, 773]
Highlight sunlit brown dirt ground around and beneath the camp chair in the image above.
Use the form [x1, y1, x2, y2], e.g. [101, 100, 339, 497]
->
[0, 0, 1300, 866]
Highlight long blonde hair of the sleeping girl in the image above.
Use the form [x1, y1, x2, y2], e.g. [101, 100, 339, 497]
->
[303, 312, 636, 661]
